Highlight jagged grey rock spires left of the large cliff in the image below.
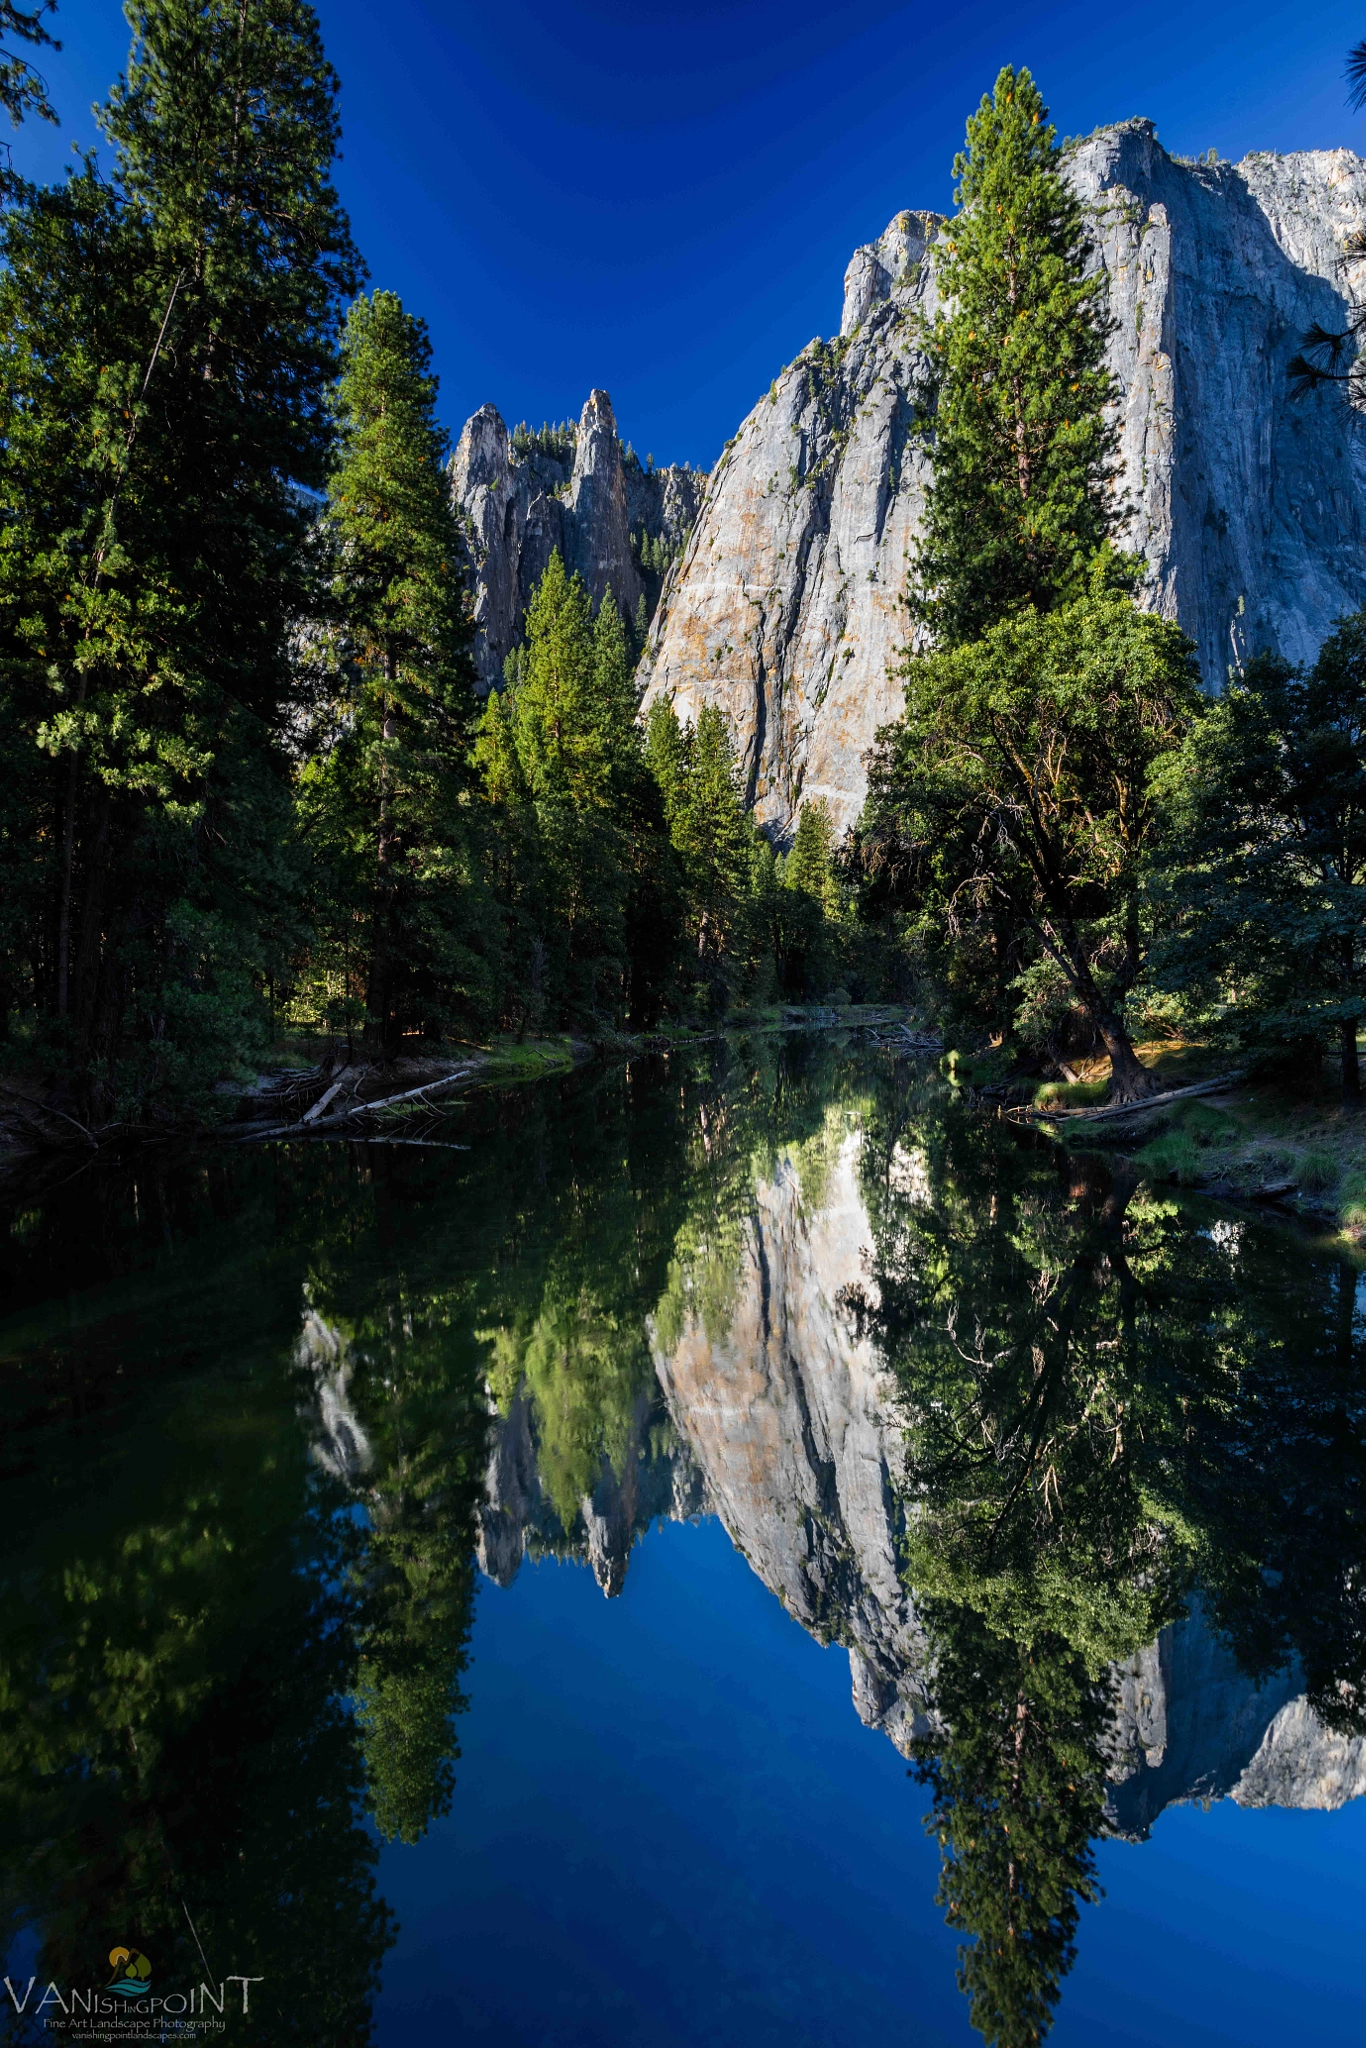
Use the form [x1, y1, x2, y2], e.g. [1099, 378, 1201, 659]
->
[451, 391, 707, 690]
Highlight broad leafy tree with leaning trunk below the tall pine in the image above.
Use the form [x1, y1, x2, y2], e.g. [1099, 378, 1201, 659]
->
[862, 590, 1198, 1096]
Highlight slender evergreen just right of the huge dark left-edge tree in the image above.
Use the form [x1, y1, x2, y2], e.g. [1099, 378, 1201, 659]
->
[303, 291, 487, 1055]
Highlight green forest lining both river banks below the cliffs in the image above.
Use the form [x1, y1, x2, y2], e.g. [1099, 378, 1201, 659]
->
[0, 12, 1366, 1133]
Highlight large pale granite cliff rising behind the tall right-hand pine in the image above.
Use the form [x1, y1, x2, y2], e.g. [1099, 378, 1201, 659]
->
[643, 121, 1366, 840]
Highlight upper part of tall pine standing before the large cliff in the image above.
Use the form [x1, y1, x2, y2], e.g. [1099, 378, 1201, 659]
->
[911, 66, 1114, 645]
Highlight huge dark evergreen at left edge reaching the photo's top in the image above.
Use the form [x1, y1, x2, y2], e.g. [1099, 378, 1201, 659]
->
[0, 0, 356, 1108]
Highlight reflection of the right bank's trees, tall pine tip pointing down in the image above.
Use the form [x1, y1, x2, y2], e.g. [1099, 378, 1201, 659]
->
[848, 1085, 1366, 2044]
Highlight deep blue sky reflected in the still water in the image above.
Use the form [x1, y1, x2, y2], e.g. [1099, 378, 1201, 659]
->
[377, 1522, 1366, 2048]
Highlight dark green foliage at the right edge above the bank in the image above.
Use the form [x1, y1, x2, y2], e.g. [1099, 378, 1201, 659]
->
[1153, 612, 1366, 1102]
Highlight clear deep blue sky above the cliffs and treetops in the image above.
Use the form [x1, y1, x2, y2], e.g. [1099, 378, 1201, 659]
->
[14, 0, 1366, 467]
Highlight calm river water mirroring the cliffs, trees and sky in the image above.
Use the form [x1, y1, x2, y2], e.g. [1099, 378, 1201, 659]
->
[0, 1038, 1366, 2048]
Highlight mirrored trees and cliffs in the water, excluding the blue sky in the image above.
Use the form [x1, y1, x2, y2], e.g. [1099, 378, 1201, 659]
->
[0, 1040, 1366, 2044]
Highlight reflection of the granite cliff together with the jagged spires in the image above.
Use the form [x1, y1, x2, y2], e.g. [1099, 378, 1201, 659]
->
[466, 1110, 1366, 1837]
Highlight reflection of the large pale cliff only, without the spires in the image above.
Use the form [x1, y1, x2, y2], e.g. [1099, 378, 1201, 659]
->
[638, 1133, 1366, 1835]
